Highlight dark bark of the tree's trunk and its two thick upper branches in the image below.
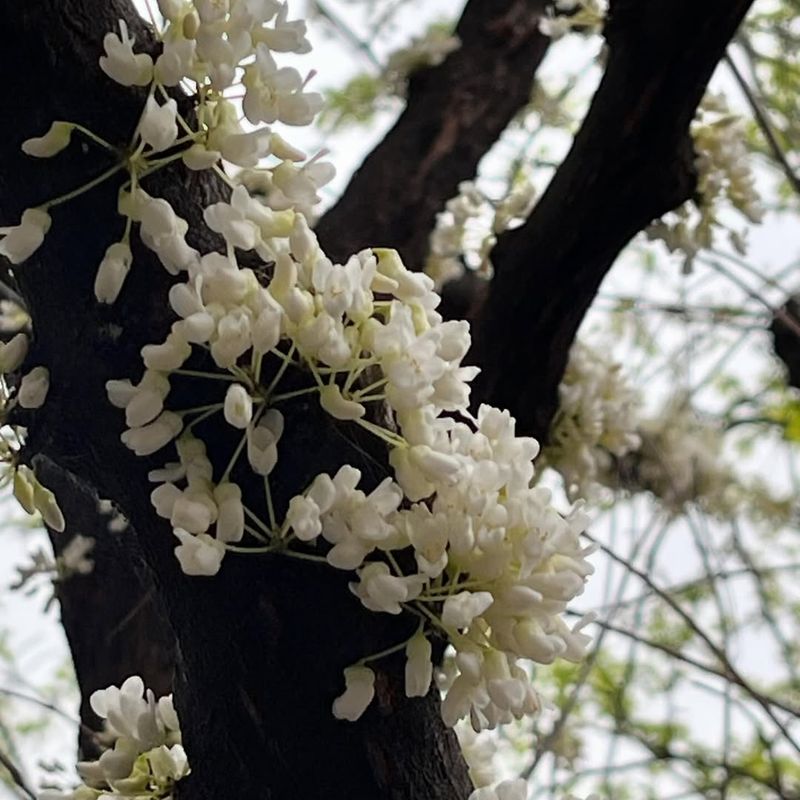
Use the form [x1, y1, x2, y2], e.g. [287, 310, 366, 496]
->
[0, 0, 749, 800]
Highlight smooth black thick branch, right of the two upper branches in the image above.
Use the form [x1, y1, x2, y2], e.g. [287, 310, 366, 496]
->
[476, 0, 752, 438]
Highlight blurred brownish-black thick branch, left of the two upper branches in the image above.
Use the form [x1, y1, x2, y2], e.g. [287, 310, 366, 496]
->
[317, 0, 549, 268]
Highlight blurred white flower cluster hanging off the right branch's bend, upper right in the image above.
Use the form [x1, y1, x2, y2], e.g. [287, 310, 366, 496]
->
[647, 94, 764, 270]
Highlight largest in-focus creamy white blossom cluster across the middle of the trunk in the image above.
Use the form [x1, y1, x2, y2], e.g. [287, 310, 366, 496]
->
[119, 211, 590, 728]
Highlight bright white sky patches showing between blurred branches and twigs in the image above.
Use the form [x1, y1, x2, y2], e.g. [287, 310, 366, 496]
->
[0, 0, 800, 798]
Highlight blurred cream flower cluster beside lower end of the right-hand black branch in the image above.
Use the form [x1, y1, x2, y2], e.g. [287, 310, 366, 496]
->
[542, 342, 640, 504]
